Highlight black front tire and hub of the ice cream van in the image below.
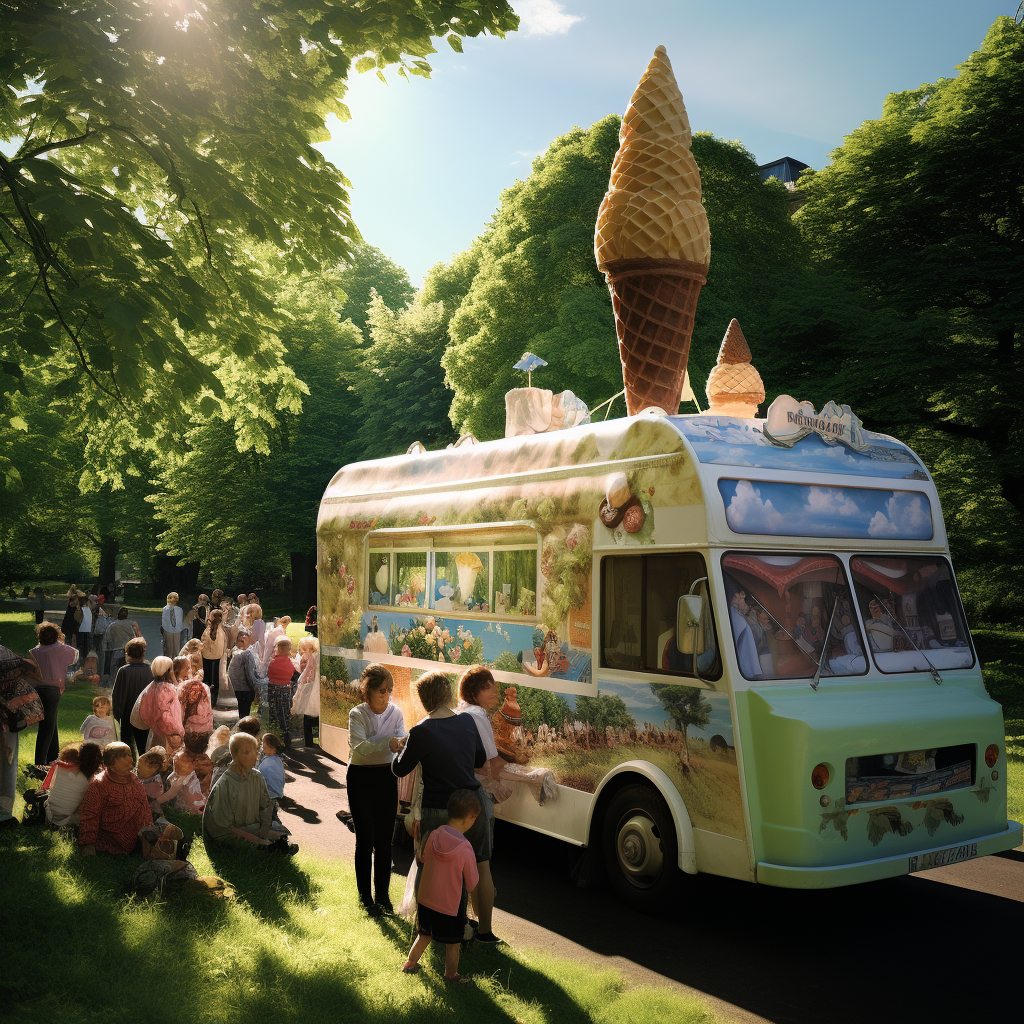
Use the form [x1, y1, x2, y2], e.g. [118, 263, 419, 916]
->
[601, 784, 679, 912]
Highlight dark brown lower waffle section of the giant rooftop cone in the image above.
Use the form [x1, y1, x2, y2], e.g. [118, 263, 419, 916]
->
[602, 258, 708, 416]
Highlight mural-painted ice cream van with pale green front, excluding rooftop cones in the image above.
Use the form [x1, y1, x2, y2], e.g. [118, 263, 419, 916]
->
[317, 393, 1022, 906]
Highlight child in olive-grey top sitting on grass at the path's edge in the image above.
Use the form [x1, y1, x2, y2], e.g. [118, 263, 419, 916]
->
[203, 732, 299, 854]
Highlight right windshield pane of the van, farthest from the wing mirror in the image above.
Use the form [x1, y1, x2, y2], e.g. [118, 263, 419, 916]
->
[850, 555, 974, 672]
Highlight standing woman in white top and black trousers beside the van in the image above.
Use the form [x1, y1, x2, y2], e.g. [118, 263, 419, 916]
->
[345, 664, 409, 918]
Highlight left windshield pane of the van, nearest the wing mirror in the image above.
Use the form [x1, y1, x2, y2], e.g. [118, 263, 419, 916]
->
[722, 551, 867, 680]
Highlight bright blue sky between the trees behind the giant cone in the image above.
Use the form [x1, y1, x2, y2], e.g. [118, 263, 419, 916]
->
[322, 0, 1017, 286]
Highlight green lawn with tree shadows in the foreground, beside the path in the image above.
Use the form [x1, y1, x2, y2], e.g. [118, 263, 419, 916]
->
[0, 685, 720, 1024]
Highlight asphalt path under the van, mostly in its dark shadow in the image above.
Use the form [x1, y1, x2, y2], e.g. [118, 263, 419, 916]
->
[283, 751, 1024, 1024]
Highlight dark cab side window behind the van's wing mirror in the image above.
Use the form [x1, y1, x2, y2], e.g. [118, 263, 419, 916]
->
[601, 552, 722, 679]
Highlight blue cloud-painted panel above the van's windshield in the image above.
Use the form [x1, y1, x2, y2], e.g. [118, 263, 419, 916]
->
[718, 480, 932, 541]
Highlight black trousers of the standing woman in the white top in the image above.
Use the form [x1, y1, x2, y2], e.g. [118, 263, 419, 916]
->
[346, 764, 398, 903]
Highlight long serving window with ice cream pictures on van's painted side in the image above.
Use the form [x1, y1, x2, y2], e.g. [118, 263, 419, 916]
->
[368, 529, 539, 620]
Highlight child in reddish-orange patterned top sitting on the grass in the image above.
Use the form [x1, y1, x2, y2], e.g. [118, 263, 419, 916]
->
[78, 742, 153, 856]
